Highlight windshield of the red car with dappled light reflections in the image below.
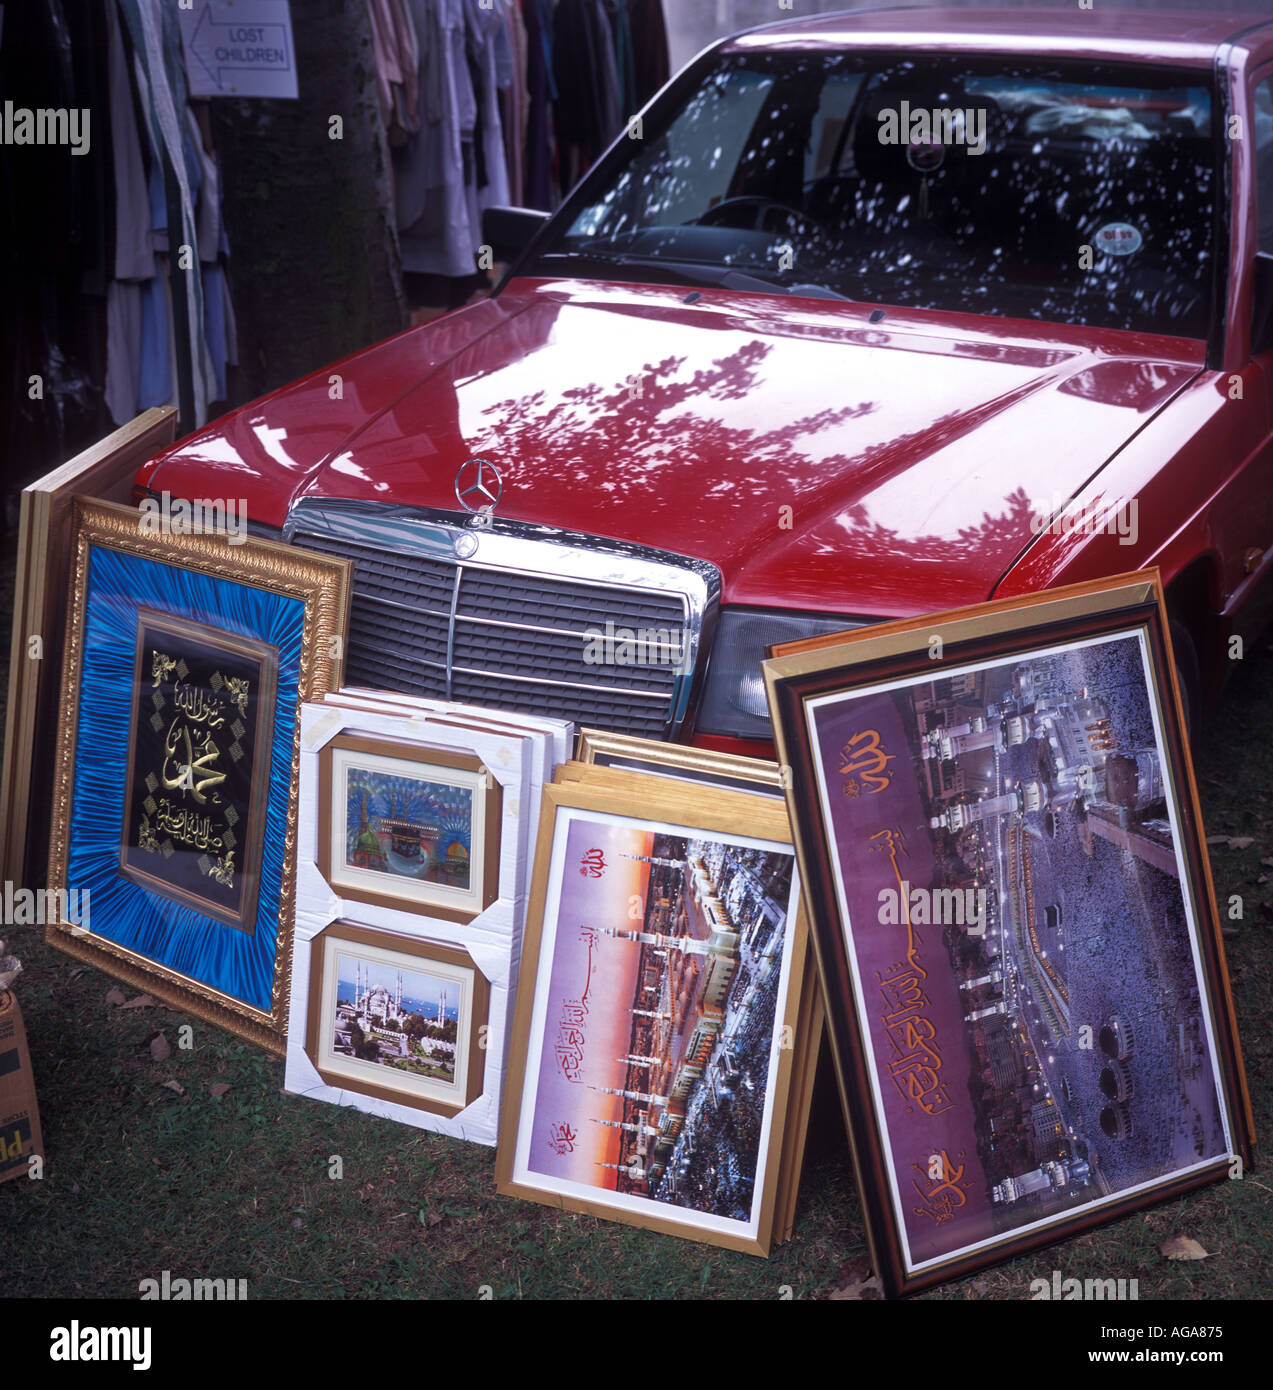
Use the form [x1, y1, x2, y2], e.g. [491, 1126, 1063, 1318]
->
[532, 53, 1217, 338]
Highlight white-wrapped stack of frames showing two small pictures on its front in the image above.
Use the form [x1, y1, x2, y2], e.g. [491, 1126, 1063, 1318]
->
[285, 691, 573, 1145]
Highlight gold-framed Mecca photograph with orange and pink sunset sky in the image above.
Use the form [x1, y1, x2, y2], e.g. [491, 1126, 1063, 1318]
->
[495, 773, 805, 1255]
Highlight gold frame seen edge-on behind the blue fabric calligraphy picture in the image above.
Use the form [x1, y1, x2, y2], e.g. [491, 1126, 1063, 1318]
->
[0, 406, 176, 888]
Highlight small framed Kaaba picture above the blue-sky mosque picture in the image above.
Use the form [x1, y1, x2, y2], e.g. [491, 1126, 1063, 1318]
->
[318, 734, 502, 922]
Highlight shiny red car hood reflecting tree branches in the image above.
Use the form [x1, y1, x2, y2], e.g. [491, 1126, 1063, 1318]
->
[147, 279, 1204, 616]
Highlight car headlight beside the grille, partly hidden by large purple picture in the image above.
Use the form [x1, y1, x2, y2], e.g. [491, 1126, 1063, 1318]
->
[695, 607, 866, 738]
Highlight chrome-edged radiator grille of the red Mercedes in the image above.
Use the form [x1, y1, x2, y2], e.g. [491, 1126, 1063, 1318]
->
[284, 502, 718, 738]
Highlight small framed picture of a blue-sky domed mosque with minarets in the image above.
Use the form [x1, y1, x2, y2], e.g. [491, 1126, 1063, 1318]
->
[306, 922, 491, 1115]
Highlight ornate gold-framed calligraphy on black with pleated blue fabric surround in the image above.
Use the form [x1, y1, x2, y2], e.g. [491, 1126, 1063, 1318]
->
[47, 498, 350, 1052]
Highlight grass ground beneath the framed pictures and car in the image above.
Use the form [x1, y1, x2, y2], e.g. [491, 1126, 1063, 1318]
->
[0, 525, 1273, 1301]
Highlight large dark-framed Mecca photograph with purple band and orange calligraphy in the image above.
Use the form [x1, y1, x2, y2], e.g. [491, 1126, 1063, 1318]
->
[764, 573, 1252, 1295]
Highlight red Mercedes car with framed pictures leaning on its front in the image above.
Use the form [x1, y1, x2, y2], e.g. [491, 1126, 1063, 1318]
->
[138, 7, 1273, 753]
